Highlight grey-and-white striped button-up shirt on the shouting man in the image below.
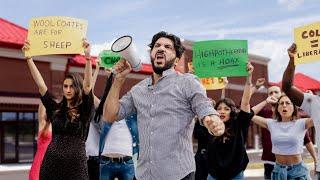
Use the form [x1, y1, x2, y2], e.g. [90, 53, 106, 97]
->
[118, 69, 218, 180]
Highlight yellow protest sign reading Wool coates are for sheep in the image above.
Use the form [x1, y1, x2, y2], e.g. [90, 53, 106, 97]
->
[25, 16, 88, 56]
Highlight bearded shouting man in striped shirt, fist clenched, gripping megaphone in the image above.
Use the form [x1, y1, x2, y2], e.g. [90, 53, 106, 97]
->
[104, 31, 224, 180]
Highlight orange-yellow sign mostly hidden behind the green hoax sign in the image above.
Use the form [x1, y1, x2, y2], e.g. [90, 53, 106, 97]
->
[188, 62, 226, 90]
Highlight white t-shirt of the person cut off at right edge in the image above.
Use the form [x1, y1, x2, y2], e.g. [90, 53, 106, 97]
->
[301, 93, 320, 172]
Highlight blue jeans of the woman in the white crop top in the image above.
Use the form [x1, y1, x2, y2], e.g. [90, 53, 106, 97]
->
[271, 162, 311, 180]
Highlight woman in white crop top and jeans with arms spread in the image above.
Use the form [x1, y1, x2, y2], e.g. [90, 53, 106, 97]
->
[252, 95, 313, 180]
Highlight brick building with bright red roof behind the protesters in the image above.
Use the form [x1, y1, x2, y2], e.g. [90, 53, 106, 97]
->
[0, 18, 269, 164]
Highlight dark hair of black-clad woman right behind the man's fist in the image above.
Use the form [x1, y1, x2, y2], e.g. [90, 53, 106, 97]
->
[214, 98, 237, 139]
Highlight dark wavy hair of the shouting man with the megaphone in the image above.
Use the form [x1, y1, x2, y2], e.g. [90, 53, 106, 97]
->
[149, 31, 184, 58]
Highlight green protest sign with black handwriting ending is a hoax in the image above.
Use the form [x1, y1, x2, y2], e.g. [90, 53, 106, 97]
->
[193, 40, 248, 78]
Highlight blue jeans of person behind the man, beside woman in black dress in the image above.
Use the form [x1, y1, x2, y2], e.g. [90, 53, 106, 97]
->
[100, 159, 134, 180]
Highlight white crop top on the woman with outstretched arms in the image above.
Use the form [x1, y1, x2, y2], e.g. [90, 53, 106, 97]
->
[267, 118, 307, 155]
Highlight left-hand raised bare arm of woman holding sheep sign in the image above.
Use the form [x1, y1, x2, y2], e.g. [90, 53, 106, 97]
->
[22, 40, 48, 96]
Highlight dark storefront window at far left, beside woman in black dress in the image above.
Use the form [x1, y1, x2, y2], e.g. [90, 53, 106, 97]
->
[0, 112, 37, 163]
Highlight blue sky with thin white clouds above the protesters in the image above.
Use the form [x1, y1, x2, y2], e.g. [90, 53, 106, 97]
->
[0, 0, 320, 82]
